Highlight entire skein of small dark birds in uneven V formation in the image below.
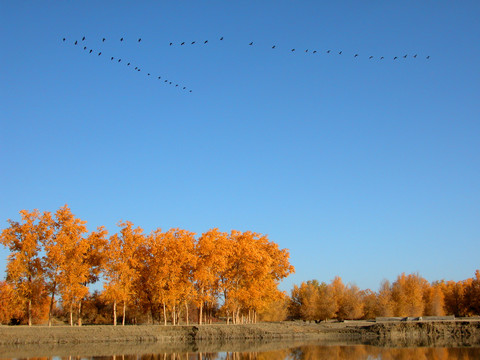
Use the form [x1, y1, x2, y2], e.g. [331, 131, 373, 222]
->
[62, 36, 430, 93]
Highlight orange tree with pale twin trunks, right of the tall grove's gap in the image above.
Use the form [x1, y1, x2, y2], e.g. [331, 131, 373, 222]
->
[104, 221, 145, 325]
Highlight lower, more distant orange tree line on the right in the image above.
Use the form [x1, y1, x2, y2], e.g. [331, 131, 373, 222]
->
[289, 270, 480, 320]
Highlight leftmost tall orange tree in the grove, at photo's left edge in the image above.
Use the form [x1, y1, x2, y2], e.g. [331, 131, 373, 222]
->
[0, 210, 45, 326]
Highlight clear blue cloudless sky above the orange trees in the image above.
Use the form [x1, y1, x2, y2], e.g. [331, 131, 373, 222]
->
[0, 0, 480, 290]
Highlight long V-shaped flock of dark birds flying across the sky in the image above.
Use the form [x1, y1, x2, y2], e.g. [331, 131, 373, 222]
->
[62, 36, 430, 93]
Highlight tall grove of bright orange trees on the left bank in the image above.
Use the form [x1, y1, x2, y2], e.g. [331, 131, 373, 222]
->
[0, 205, 294, 326]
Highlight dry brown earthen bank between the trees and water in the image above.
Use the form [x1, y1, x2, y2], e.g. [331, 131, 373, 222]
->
[0, 320, 480, 358]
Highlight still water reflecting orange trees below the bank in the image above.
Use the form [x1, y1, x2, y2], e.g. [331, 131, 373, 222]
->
[6, 345, 480, 360]
